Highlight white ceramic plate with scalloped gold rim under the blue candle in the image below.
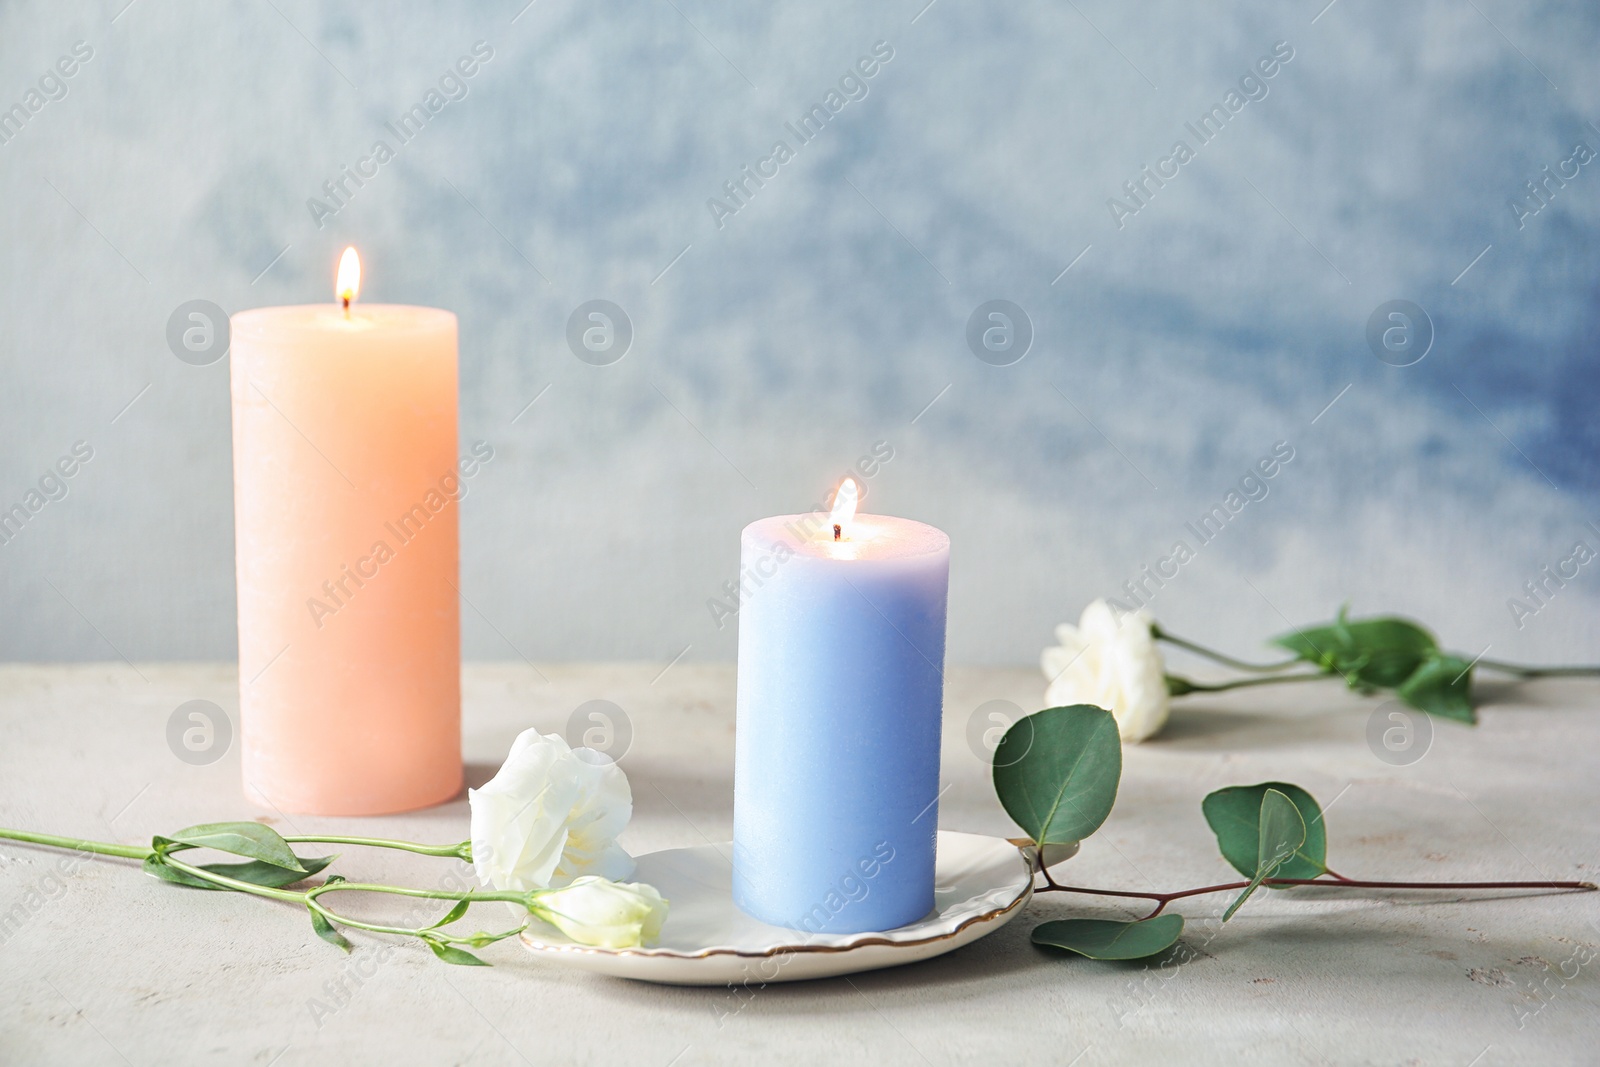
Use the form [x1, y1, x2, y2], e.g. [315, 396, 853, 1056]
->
[522, 830, 1056, 985]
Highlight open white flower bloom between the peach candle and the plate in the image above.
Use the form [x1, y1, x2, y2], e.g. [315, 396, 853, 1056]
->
[467, 729, 634, 891]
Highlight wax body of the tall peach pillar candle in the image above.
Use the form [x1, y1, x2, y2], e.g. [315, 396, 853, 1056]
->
[230, 286, 462, 816]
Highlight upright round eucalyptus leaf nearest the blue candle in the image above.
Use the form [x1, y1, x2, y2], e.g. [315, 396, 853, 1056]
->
[994, 704, 1122, 845]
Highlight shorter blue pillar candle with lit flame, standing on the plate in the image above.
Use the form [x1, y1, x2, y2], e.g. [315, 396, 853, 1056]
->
[733, 480, 950, 934]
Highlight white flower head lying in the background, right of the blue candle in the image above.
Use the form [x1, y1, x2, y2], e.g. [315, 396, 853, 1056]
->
[1040, 600, 1171, 744]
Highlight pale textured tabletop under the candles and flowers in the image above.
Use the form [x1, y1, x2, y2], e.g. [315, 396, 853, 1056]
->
[0, 664, 1600, 1067]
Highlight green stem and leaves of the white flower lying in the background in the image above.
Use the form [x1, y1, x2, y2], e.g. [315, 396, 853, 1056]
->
[1150, 605, 1600, 723]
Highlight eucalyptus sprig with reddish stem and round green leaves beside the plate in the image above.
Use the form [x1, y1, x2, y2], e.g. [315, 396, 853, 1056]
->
[994, 703, 1595, 960]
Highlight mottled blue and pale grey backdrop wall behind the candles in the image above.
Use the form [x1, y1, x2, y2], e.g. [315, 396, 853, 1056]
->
[0, 0, 1600, 662]
